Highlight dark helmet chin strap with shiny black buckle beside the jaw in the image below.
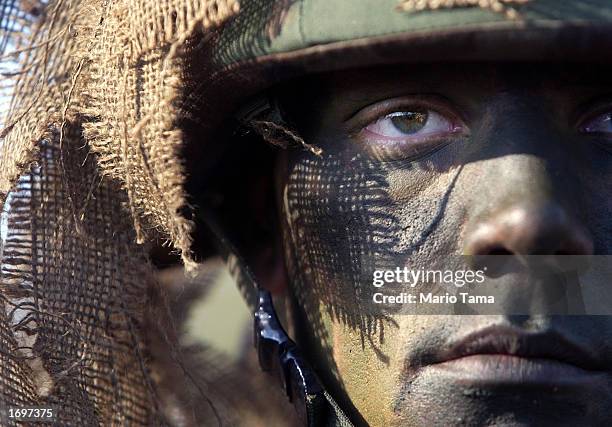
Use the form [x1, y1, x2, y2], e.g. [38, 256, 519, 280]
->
[202, 211, 353, 427]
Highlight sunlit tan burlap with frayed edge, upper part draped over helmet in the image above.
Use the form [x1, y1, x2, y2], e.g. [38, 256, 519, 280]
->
[0, 0, 239, 271]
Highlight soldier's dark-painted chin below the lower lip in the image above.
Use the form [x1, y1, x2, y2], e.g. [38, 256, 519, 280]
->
[394, 370, 612, 426]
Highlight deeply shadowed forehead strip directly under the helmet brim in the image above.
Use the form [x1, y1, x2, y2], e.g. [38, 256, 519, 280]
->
[280, 62, 612, 118]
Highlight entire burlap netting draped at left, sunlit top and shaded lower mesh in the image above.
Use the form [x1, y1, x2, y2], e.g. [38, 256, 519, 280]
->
[0, 0, 238, 425]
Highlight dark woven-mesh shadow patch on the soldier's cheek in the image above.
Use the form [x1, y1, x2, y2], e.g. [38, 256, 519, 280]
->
[283, 157, 394, 307]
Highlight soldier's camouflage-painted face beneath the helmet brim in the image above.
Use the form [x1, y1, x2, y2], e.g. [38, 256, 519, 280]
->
[278, 64, 612, 426]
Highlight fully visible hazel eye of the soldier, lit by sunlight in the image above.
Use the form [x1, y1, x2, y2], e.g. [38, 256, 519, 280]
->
[355, 100, 468, 161]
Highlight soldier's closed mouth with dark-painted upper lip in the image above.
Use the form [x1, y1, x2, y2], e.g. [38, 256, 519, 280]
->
[424, 326, 606, 391]
